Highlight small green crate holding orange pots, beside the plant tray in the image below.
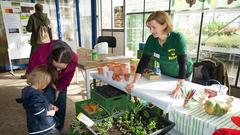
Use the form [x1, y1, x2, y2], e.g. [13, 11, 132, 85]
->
[75, 99, 109, 121]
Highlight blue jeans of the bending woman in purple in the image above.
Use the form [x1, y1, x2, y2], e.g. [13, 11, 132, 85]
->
[43, 87, 67, 130]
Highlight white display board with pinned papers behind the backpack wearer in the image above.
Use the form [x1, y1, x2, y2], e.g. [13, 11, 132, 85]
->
[0, 1, 49, 60]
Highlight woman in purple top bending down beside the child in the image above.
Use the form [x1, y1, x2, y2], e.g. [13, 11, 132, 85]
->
[27, 41, 78, 130]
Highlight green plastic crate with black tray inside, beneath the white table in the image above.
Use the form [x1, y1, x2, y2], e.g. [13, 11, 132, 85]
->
[91, 85, 130, 114]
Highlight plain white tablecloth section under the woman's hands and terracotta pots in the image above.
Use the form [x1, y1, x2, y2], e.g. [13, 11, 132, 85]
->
[91, 73, 204, 113]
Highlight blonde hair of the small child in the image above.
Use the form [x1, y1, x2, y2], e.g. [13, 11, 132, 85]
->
[27, 66, 51, 89]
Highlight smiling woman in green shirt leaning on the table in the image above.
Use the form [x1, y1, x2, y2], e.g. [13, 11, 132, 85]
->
[126, 11, 193, 98]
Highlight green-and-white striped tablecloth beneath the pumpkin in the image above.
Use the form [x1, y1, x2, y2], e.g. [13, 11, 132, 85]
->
[169, 98, 240, 135]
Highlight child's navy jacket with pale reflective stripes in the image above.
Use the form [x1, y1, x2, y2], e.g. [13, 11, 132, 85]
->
[22, 86, 56, 135]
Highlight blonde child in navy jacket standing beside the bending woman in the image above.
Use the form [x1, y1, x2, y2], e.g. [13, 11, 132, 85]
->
[21, 67, 58, 135]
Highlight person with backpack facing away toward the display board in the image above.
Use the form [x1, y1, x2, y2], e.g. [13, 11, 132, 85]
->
[21, 3, 52, 79]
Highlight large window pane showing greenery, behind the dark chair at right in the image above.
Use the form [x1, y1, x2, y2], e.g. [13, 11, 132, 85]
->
[200, 11, 240, 85]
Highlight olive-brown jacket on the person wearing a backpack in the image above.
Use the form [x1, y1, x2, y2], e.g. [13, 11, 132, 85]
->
[26, 12, 52, 47]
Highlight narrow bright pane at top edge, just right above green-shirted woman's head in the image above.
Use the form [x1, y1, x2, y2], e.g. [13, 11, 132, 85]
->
[171, 0, 204, 10]
